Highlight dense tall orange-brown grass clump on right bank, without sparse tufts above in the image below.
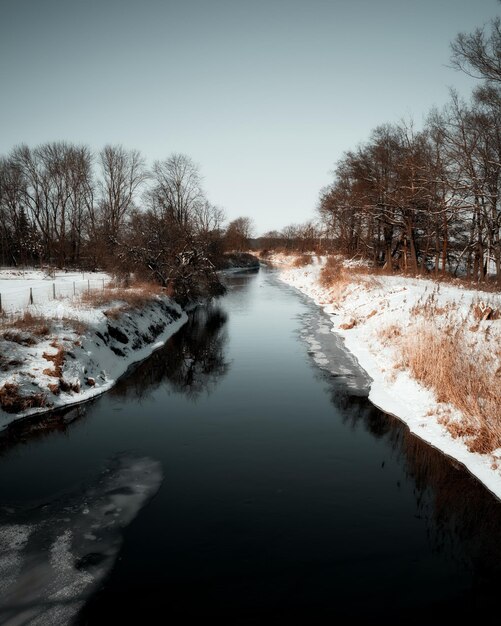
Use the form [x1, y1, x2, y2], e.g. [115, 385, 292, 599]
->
[398, 325, 501, 454]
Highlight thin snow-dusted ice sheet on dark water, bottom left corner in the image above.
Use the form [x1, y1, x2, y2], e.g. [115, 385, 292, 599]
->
[0, 455, 163, 626]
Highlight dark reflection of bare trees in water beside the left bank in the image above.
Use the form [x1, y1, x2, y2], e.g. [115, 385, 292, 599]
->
[110, 305, 230, 401]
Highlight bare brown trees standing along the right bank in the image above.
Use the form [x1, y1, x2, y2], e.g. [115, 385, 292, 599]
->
[319, 19, 501, 282]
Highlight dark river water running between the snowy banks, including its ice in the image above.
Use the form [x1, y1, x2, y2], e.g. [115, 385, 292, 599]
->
[0, 271, 501, 624]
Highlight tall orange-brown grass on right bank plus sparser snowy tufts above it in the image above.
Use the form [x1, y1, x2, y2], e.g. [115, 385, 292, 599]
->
[379, 289, 501, 454]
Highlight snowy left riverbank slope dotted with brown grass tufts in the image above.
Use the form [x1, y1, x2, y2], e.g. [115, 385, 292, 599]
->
[0, 285, 187, 428]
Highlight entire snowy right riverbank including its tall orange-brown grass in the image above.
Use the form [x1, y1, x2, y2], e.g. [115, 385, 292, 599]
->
[270, 255, 501, 498]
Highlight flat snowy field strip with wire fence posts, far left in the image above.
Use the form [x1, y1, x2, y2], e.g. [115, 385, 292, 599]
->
[0, 278, 108, 314]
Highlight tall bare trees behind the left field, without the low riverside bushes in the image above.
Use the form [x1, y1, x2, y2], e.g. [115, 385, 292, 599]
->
[0, 147, 218, 267]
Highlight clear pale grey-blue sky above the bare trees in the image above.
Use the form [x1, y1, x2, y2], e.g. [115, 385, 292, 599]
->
[0, 0, 501, 233]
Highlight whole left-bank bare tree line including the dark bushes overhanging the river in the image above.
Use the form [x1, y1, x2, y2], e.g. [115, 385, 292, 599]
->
[0, 142, 256, 295]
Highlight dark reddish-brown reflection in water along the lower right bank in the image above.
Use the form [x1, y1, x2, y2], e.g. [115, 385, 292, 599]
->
[331, 380, 501, 588]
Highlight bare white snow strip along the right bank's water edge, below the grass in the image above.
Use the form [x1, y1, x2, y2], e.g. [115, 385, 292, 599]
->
[278, 264, 501, 499]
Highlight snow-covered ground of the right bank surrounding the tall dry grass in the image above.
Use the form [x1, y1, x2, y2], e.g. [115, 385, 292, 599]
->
[271, 255, 501, 498]
